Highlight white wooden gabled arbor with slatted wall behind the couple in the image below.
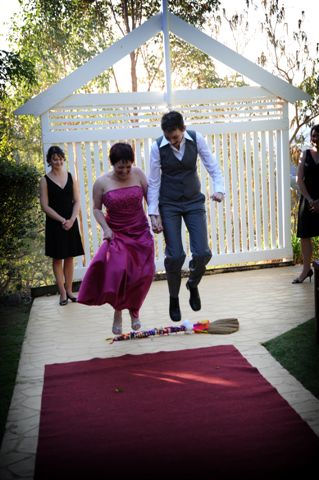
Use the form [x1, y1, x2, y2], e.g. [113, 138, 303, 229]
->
[15, 1, 310, 279]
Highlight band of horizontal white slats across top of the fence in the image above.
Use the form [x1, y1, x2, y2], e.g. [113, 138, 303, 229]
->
[48, 89, 284, 132]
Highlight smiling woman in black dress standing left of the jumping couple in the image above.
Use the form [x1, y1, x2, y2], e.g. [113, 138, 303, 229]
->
[40, 146, 84, 305]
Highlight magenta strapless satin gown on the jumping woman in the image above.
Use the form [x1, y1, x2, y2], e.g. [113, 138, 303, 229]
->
[78, 186, 155, 317]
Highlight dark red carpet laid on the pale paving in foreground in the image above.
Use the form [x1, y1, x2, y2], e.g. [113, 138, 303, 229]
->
[35, 346, 319, 480]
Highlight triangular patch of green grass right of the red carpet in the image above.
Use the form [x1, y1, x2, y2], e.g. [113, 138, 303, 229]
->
[263, 318, 319, 398]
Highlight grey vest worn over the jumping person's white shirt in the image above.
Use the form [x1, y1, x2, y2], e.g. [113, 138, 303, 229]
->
[156, 130, 201, 204]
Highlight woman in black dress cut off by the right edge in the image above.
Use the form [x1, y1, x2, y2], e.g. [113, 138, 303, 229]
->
[292, 124, 319, 283]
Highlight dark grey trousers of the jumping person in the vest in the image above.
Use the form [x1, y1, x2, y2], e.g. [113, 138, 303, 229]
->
[160, 195, 212, 297]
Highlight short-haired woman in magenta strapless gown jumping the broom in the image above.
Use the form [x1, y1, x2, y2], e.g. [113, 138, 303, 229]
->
[78, 143, 155, 335]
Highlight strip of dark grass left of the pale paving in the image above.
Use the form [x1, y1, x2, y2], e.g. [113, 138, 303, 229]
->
[0, 305, 31, 442]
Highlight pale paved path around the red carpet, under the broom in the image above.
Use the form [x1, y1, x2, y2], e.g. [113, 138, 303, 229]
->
[0, 267, 319, 480]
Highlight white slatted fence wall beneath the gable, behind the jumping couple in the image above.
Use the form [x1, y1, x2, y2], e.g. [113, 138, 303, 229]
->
[42, 87, 291, 279]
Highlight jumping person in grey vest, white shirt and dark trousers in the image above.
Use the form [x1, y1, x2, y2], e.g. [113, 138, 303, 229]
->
[147, 111, 224, 322]
